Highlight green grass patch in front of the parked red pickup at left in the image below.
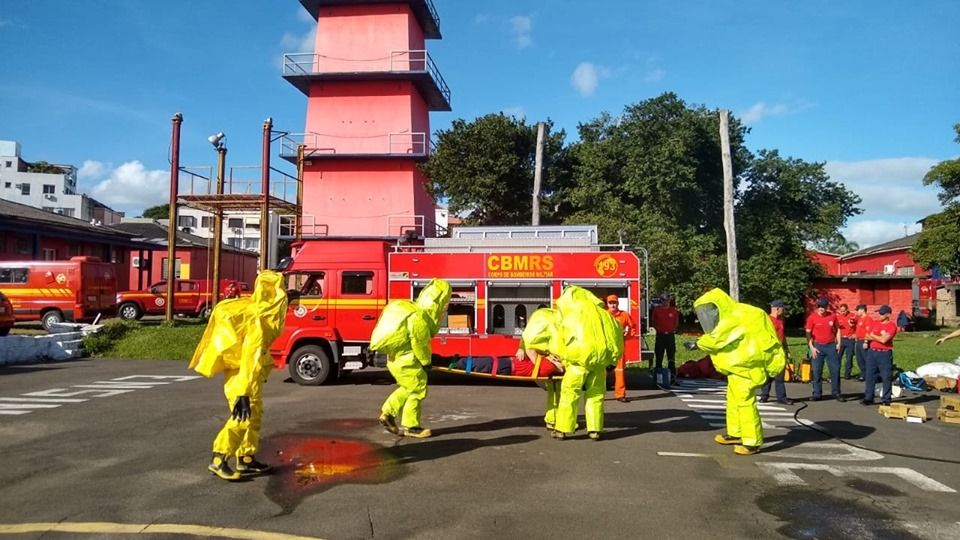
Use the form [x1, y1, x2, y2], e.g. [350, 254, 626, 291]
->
[84, 319, 206, 360]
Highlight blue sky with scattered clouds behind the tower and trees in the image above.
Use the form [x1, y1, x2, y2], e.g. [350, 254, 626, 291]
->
[0, 0, 960, 246]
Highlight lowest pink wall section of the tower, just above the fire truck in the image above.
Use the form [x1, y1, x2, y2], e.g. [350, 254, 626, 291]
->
[303, 159, 434, 236]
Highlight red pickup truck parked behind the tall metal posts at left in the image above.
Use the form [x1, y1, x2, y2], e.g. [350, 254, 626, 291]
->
[117, 279, 250, 321]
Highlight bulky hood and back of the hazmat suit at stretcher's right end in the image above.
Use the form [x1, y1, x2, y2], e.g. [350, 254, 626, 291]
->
[557, 285, 623, 369]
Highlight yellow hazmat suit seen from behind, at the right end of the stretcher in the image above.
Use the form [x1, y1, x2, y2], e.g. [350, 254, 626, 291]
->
[556, 285, 623, 439]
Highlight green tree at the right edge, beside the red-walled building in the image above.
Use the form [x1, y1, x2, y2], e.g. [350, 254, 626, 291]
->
[910, 124, 960, 275]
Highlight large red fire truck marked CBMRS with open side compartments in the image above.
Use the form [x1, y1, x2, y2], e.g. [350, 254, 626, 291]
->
[270, 225, 646, 385]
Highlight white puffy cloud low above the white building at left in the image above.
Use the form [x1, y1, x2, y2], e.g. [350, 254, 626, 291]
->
[84, 160, 170, 215]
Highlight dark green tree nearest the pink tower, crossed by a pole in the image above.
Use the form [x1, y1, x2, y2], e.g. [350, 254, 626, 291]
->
[421, 113, 569, 225]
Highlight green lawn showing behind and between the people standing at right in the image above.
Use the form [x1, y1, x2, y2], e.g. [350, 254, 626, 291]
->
[664, 329, 960, 373]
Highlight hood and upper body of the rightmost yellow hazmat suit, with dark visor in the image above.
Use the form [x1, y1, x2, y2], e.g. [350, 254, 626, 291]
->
[693, 289, 786, 386]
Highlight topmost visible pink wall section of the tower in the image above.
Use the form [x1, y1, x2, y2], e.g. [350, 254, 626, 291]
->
[315, 3, 425, 67]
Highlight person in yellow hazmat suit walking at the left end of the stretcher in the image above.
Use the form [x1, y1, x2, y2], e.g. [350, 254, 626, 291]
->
[370, 279, 451, 438]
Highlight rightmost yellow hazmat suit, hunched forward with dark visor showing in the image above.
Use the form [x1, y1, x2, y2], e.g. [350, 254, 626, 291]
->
[693, 289, 786, 453]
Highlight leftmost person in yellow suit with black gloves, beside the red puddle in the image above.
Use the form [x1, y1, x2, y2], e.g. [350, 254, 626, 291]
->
[190, 270, 287, 480]
